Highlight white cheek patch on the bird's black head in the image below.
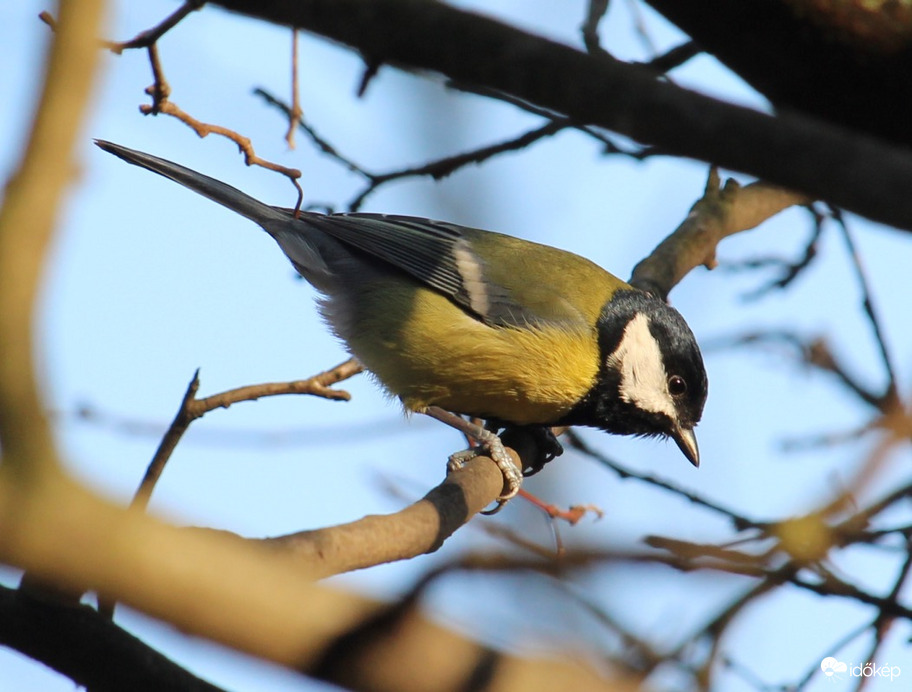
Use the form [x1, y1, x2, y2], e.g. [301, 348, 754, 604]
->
[607, 315, 677, 420]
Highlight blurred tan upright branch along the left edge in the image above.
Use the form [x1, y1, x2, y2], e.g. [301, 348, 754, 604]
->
[0, 0, 104, 604]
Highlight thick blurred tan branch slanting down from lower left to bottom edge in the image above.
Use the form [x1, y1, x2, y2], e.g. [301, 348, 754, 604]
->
[0, 470, 634, 692]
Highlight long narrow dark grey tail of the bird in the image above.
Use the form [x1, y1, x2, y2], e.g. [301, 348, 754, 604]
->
[95, 139, 288, 226]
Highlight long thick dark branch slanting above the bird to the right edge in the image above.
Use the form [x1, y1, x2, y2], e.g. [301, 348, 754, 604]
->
[217, 0, 912, 229]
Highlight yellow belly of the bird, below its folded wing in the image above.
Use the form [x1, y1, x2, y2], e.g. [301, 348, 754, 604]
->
[338, 282, 599, 425]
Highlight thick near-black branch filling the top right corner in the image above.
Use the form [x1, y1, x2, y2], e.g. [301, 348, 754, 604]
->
[647, 0, 912, 146]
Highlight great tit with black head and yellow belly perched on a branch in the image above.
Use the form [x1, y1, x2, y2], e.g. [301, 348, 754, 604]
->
[95, 140, 708, 513]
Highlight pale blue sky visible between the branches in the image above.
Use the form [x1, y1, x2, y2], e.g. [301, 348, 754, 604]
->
[0, 0, 912, 691]
